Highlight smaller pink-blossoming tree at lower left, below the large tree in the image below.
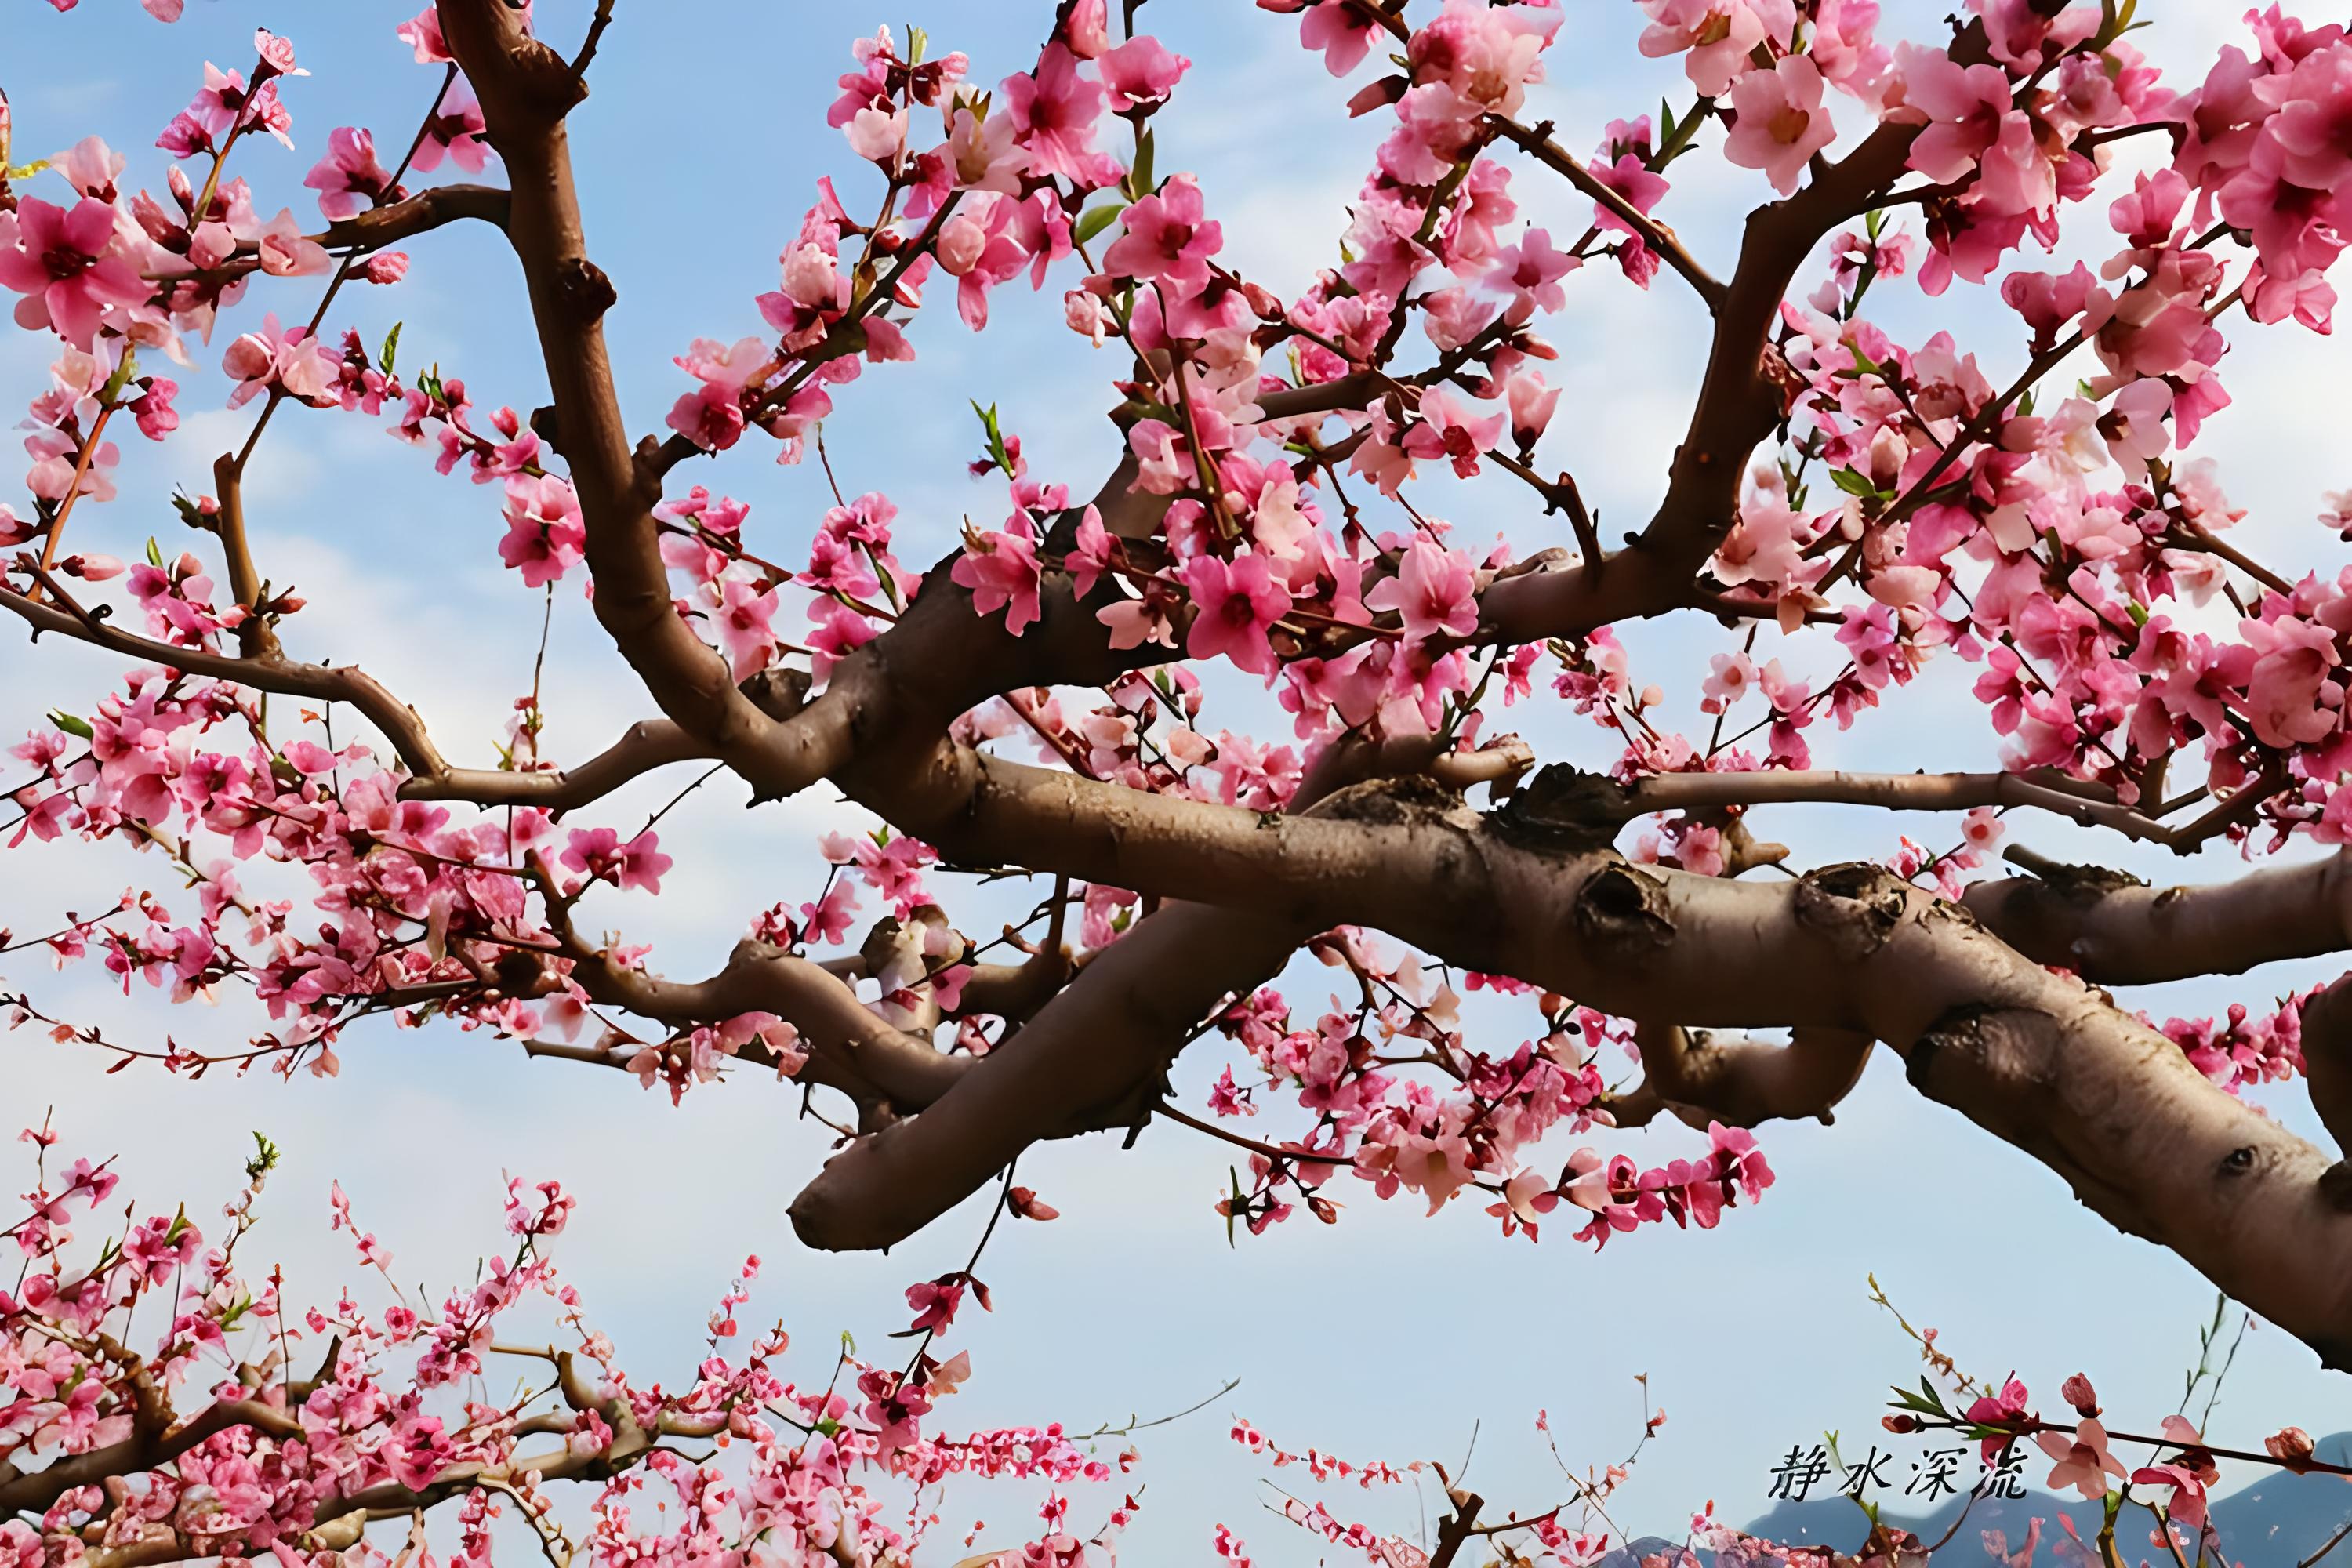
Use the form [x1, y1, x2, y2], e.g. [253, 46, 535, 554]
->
[0, 1126, 1136, 1568]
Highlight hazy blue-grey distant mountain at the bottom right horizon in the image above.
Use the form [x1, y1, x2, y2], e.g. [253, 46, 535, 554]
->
[1595, 1432, 2352, 1568]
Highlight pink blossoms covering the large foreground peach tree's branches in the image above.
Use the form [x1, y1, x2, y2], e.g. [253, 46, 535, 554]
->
[0, 0, 2352, 1544]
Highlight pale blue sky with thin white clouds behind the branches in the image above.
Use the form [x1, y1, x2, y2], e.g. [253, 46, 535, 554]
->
[0, 0, 2352, 1563]
